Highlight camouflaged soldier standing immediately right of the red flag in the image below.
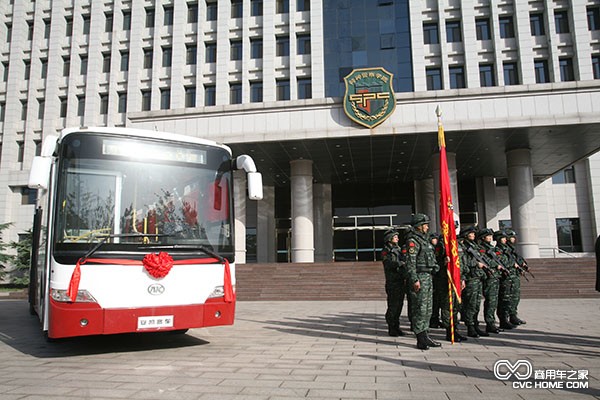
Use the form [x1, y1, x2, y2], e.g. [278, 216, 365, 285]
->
[460, 227, 489, 337]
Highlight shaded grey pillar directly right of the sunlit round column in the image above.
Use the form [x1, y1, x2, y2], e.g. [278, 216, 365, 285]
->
[313, 183, 333, 262]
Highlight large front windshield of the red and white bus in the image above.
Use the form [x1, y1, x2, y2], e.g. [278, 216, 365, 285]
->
[54, 133, 233, 258]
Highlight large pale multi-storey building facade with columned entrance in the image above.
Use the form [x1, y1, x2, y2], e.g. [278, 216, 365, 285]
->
[0, 0, 600, 268]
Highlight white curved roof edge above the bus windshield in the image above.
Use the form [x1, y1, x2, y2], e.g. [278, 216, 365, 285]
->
[58, 126, 232, 154]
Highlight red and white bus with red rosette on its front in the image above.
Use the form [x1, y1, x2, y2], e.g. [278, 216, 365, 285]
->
[29, 128, 262, 339]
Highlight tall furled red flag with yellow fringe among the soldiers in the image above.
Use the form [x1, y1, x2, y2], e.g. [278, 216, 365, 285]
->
[438, 120, 461, 303]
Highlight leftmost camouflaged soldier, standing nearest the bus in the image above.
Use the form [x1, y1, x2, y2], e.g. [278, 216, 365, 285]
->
[381, 230, 406, 337]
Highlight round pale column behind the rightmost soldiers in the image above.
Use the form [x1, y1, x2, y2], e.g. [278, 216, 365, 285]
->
[506, 149, 540, 258]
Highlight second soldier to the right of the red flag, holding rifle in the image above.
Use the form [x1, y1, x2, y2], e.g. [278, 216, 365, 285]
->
[477, 228, 504, 333]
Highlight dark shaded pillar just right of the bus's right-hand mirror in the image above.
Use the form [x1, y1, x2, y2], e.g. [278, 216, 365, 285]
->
[256, 186, 277, 263]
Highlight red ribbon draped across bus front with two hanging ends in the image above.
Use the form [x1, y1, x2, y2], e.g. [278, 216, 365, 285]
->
[67, 253, 235, 303]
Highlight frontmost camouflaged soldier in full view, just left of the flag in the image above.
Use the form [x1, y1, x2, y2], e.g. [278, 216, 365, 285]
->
[406, 213, 441, 350]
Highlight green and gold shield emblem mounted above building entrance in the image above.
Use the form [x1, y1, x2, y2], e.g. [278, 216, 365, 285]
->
[344, 67, 396, 128]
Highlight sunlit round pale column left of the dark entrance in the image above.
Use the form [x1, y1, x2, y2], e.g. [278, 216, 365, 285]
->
[290, 160, 315, 263]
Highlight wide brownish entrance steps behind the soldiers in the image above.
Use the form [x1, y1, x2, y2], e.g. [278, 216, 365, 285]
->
[236, 257, 600, 301]
